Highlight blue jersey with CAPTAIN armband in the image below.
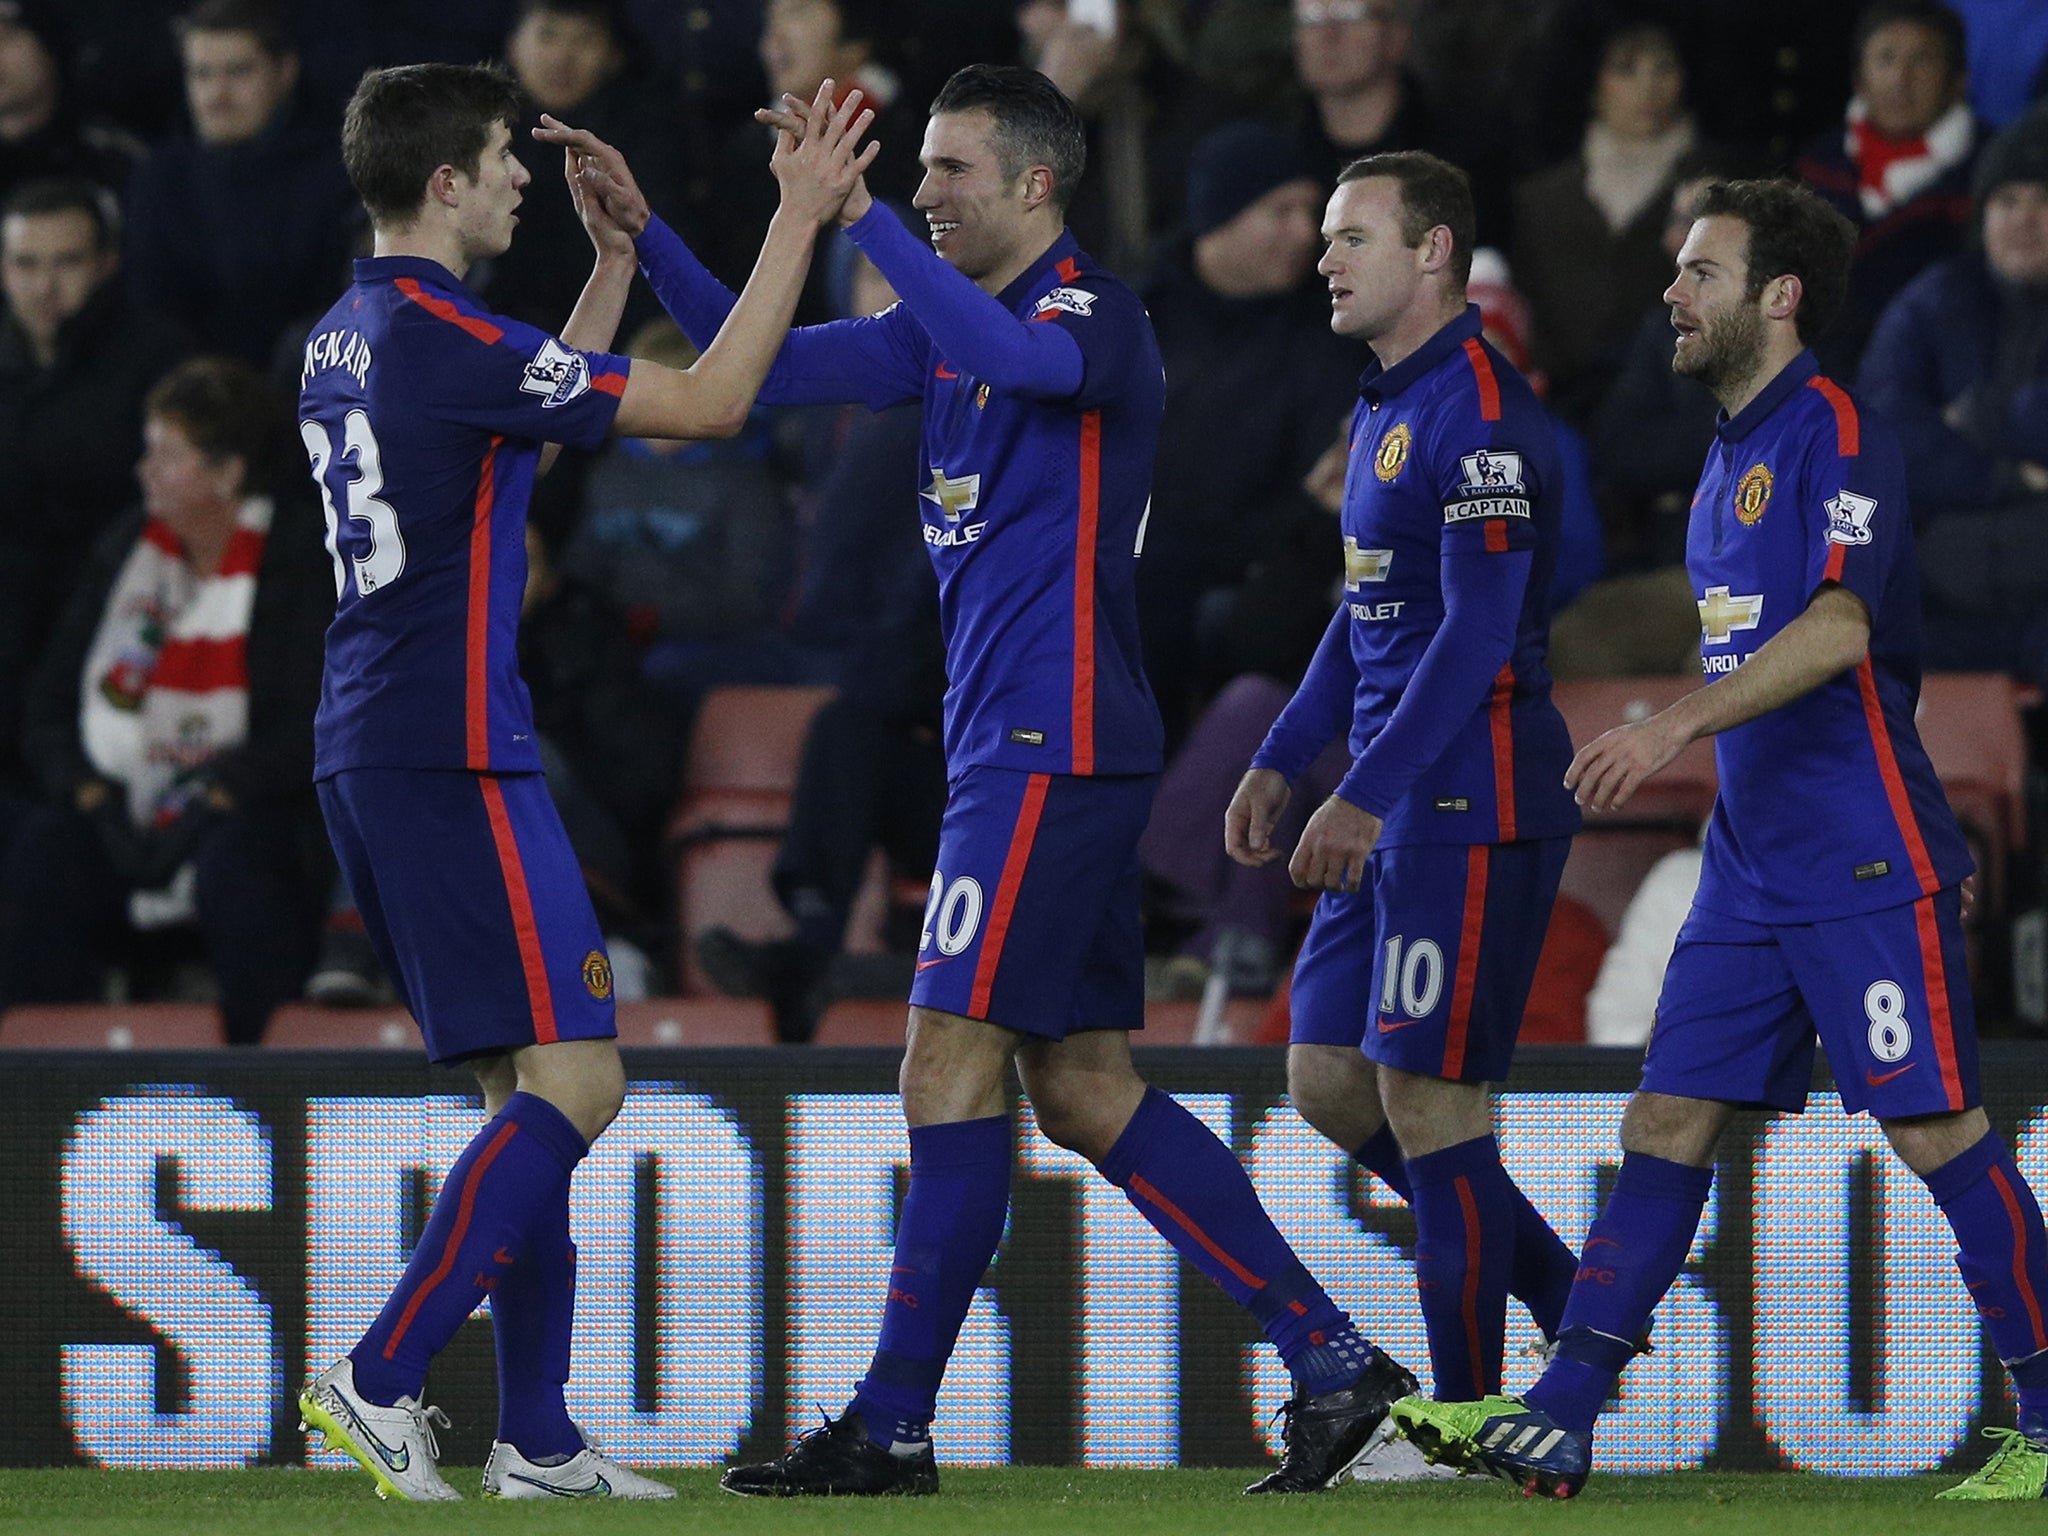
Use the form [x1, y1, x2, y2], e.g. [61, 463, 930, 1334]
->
[1339, 305, 1579, 848]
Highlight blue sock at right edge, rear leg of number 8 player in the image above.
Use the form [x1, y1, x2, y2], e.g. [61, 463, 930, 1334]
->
[1927, 1133, 2048, 1417]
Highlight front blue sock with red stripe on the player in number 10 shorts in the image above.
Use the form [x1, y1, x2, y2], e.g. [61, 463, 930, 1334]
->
[1407, 1137, 1518, 1403]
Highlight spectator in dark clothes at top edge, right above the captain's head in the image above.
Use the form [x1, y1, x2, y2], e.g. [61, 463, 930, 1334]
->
[1294, 0, 1509, 246]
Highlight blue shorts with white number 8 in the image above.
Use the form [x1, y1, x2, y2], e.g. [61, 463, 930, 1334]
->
[1642, 887, 1980, 1120]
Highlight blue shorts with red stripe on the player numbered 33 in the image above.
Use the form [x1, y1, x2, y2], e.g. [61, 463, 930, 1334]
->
[319, 768, 616, 1061]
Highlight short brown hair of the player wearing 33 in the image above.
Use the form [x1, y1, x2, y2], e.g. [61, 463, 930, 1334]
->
[342, 63, 524, 227]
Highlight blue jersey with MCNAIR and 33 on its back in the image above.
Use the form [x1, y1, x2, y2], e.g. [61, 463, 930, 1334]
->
[299, 256, 631, 778]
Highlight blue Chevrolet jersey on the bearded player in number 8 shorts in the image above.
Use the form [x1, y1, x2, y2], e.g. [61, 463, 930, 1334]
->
[1686, 352, 1970, 924]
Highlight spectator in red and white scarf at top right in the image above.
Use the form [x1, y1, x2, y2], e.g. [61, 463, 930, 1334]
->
[1798, 0, 1978, 377]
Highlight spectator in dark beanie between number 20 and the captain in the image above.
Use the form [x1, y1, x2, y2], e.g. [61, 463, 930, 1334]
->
[1139, 123, 1366, 741]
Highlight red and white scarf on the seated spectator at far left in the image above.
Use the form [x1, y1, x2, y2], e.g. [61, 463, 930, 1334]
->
[78, 496, 272, 928]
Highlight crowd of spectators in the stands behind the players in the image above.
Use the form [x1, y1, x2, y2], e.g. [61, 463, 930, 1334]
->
[0, 0, 2048, 1040]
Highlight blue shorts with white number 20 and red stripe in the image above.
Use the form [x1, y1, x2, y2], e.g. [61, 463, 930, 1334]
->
[909, 768, 1159, 1040]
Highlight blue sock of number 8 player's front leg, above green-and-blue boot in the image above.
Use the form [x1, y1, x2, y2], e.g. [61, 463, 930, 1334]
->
[1528, 1153, 1714, 1434]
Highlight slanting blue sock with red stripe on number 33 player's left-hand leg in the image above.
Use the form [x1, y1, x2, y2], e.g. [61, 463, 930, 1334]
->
[348, 1094, 590, 1407]
